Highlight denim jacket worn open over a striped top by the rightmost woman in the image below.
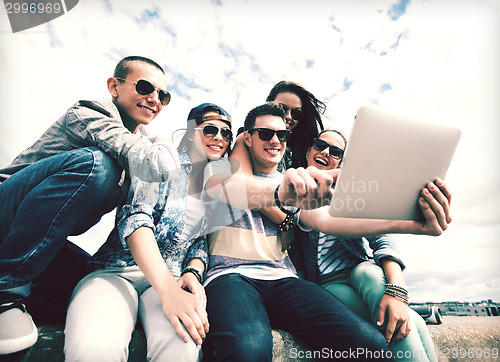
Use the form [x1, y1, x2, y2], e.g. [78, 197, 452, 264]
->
[290, 230, 405, 283]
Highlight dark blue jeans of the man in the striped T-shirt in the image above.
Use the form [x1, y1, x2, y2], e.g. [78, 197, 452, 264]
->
[202, 274, 388, 361]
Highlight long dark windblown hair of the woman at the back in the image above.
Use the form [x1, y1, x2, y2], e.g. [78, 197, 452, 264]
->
[266, 80, 326, 168]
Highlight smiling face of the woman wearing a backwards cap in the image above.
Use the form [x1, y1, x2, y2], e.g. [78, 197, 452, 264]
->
[190, 112, 229, 163]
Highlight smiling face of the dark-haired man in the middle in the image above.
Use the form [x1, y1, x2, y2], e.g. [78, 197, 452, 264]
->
[244, 115, 286, 173]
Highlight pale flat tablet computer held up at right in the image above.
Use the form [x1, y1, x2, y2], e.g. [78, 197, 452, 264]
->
[329, 106, 461, 220]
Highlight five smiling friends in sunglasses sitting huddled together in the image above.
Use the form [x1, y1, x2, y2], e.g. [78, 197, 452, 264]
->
[0, 56, 451, 362]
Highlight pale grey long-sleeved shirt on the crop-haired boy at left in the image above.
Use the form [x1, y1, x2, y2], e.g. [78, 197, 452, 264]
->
[0, 99, 180, 182]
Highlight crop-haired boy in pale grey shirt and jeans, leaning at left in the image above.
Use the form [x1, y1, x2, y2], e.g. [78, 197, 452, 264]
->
[0, 56, 179, 354]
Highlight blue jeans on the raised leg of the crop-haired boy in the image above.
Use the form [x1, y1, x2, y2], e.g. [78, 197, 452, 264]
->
[0, 147, 122, 294]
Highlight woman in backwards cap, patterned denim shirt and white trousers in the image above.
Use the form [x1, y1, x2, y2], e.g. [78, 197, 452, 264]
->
[65, 103, 231, 361]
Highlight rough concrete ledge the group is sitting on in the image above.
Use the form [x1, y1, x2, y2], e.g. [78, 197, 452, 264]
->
[0, 317, 500, 362]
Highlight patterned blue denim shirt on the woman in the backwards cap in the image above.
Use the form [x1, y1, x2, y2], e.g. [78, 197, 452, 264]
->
[90, 153, 214, 277]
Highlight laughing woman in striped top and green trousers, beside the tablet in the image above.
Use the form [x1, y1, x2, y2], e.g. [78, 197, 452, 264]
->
[290, 130, 437, 361]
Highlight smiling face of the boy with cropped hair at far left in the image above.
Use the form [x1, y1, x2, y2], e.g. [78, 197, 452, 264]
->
[108, 61, 167, 132]
